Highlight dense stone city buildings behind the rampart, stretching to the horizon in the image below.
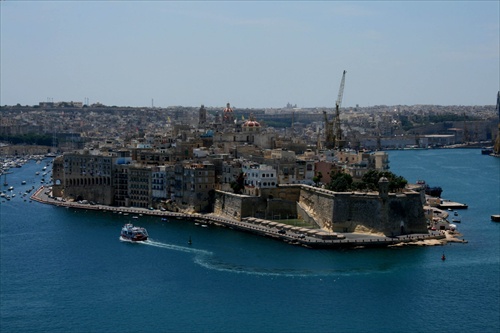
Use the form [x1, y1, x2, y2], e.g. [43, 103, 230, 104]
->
[0, 102, 498, 215]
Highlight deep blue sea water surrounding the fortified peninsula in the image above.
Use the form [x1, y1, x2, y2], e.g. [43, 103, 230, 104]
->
[0, 149, 500, 332]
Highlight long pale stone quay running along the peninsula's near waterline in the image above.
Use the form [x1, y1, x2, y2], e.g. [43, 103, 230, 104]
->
[31, 186, 447, 249]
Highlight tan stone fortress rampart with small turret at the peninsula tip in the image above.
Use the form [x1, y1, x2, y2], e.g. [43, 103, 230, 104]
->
[214, 179, 427, 236]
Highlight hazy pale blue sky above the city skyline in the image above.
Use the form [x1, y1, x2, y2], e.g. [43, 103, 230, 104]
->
[0, 0, 500, 108]
